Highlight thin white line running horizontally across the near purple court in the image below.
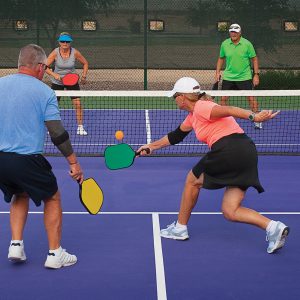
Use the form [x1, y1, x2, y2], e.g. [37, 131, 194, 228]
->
[0, 211, 300, 215]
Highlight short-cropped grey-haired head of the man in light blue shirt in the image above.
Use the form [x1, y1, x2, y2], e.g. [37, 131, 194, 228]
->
[18, 44, 47, 68]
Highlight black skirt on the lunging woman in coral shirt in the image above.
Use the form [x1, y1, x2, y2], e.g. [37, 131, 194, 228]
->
[192, 133, 264, 193]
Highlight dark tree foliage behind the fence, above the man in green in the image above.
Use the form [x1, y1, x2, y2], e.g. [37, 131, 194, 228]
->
[187, 0, 295, 52]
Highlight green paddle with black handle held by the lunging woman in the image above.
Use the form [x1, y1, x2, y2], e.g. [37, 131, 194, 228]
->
[104, 143, 150, 170]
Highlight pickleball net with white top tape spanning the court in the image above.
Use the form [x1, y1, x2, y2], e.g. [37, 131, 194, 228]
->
[45, 90, 300, 156]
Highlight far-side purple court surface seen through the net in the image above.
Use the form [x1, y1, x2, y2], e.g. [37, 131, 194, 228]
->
[45, 110, 300, 154]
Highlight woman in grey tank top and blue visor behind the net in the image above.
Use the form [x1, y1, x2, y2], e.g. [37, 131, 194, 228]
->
[46, 32, 88, 135]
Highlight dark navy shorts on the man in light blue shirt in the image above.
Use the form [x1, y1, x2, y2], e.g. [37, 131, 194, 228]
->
[0, 152, 58, 206]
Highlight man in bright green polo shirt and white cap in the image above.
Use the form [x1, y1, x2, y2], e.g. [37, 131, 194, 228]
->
[216, 24, 262, 129]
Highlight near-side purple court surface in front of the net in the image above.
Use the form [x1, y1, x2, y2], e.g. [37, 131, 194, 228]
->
[0, 156, 300, 300]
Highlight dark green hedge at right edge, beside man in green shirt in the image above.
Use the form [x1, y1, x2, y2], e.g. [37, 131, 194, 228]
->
[257, 71, 300, 90]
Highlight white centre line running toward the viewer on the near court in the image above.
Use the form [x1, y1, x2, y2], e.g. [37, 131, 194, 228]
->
[152, 213, 167, 300]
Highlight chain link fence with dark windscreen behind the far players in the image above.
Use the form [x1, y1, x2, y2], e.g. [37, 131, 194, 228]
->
[0, 0, 300, 90]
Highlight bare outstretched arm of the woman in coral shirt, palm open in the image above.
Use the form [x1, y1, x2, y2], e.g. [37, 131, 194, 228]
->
[210, 105, 280, 122]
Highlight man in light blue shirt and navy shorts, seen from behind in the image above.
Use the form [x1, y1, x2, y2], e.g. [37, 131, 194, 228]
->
[0, 44, 83, 269]
